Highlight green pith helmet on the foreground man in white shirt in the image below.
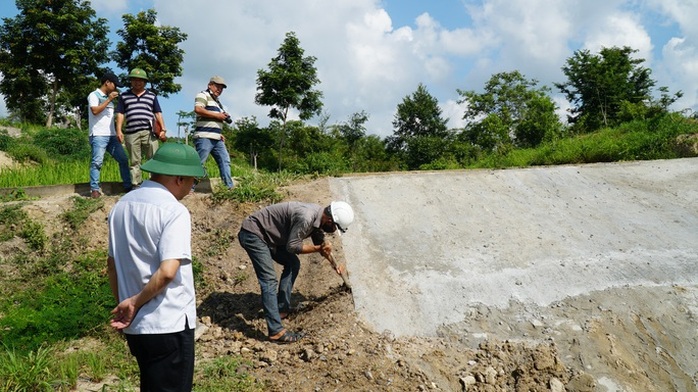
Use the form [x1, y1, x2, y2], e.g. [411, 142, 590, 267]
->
[141, 143, 206, 177]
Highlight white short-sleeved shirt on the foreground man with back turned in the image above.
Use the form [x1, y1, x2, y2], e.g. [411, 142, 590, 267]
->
[108, 181, 196, 335]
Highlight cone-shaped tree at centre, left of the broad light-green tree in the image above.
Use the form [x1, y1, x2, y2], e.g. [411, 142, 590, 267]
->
[387, 83, 450, 169]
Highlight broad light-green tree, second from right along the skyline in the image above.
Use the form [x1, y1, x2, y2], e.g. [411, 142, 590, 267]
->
[457, 71, 561, 151]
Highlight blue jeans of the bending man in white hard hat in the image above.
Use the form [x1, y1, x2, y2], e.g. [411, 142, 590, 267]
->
[238, 229, 301, 336]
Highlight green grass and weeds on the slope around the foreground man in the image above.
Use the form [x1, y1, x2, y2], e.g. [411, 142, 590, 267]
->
[0, 178, 264, 392]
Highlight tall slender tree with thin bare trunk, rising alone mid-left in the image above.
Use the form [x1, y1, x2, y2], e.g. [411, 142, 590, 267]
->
[255, 31, 322, 170]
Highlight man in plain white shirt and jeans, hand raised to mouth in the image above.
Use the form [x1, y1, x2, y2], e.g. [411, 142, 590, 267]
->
[87, 72, 131, 198]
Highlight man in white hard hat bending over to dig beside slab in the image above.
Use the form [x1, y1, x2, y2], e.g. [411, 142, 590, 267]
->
[238, 201, 354, 343]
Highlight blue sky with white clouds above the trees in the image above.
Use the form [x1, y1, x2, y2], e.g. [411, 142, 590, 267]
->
[0, 0, 698, 137]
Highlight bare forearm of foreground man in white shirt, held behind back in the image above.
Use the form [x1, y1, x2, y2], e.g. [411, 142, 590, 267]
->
[111, 259, 181, 330]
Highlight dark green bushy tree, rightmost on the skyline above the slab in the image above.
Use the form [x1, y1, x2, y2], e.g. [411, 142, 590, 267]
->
[555, 46, 656, 131]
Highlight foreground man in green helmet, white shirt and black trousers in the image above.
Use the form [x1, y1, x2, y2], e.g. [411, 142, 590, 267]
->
[107, 143, 205, 392]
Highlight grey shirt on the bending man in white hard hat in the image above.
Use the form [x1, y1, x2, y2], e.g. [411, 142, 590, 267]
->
[242, 201, 325, 254]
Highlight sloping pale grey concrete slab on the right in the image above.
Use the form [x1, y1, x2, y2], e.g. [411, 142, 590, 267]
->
[330, 158, 698, 336]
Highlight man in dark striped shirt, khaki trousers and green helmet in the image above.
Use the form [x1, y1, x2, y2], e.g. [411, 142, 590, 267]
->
[116, 68, 167, 187]
